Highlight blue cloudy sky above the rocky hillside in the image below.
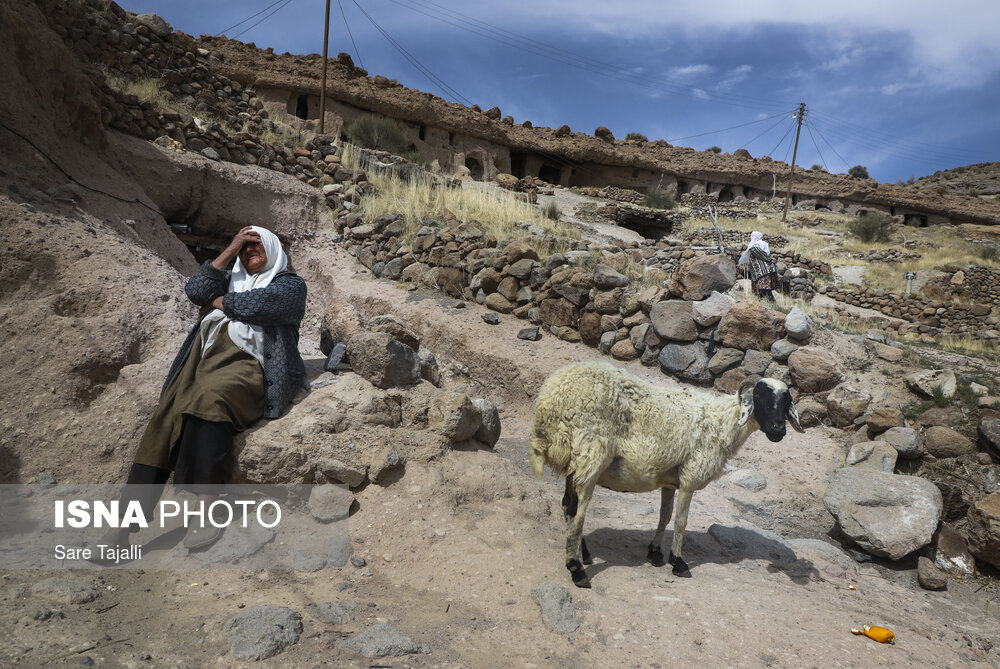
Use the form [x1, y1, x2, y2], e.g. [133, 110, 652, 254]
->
[119, 0, 1000, 182]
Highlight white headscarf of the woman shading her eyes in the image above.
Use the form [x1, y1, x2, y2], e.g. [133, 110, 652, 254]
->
[201, 225, 288, 364]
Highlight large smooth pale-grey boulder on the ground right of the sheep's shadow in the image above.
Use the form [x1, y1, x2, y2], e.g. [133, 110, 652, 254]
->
[823, 467, 943, 560]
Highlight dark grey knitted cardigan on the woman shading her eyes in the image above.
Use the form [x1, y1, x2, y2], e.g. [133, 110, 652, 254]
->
[160, 261, 306, 418]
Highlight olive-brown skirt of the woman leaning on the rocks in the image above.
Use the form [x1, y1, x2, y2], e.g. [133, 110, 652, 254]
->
[134, 326, 264, 469]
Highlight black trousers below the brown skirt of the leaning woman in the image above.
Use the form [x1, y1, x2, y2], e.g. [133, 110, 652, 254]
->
[121, 415, 233, 531]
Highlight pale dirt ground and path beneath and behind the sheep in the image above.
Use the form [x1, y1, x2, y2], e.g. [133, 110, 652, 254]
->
[0, 217, 1000, 667]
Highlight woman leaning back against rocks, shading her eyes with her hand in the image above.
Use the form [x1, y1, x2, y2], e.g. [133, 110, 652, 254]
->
[103, 226, 306, 549]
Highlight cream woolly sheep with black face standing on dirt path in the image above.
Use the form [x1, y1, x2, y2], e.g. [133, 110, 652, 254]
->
[530, 362, 803, 588]
